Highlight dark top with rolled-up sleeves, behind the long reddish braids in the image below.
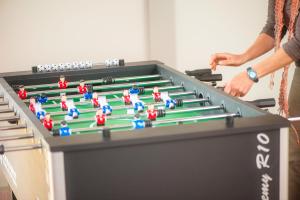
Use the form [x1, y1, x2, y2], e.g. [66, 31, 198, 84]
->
[262, 0, 300, 67]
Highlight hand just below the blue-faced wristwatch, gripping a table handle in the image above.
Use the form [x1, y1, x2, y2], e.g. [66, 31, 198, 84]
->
[224, 72, 254, 97]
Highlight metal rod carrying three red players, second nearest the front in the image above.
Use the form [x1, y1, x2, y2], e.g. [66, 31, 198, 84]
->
[54, 106, 224, 124]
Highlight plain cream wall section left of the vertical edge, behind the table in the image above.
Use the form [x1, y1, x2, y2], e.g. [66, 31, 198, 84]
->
[0, 0, 149, 72]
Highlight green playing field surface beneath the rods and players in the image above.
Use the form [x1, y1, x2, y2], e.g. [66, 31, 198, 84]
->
[21, 75, 224, 134]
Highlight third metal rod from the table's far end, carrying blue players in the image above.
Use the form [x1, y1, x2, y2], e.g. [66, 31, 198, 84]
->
[23, 85, 183, 103]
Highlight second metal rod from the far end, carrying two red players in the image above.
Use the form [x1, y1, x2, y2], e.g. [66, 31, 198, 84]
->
[27, 80, 172, 96]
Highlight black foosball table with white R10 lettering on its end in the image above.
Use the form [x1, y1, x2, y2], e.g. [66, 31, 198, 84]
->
[0, 61, 289, 200]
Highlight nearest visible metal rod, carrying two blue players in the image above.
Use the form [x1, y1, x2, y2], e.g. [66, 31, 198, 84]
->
[72, 113, 239, 133]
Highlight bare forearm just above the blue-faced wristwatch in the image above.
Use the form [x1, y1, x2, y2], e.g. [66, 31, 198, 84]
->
[253, 48, 294, 78]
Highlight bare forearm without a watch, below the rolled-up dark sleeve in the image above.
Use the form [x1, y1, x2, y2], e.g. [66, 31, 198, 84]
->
[242, 33, 274, 63]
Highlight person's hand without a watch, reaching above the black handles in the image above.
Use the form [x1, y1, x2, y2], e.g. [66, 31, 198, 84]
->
[209, 53, 246, 71]
